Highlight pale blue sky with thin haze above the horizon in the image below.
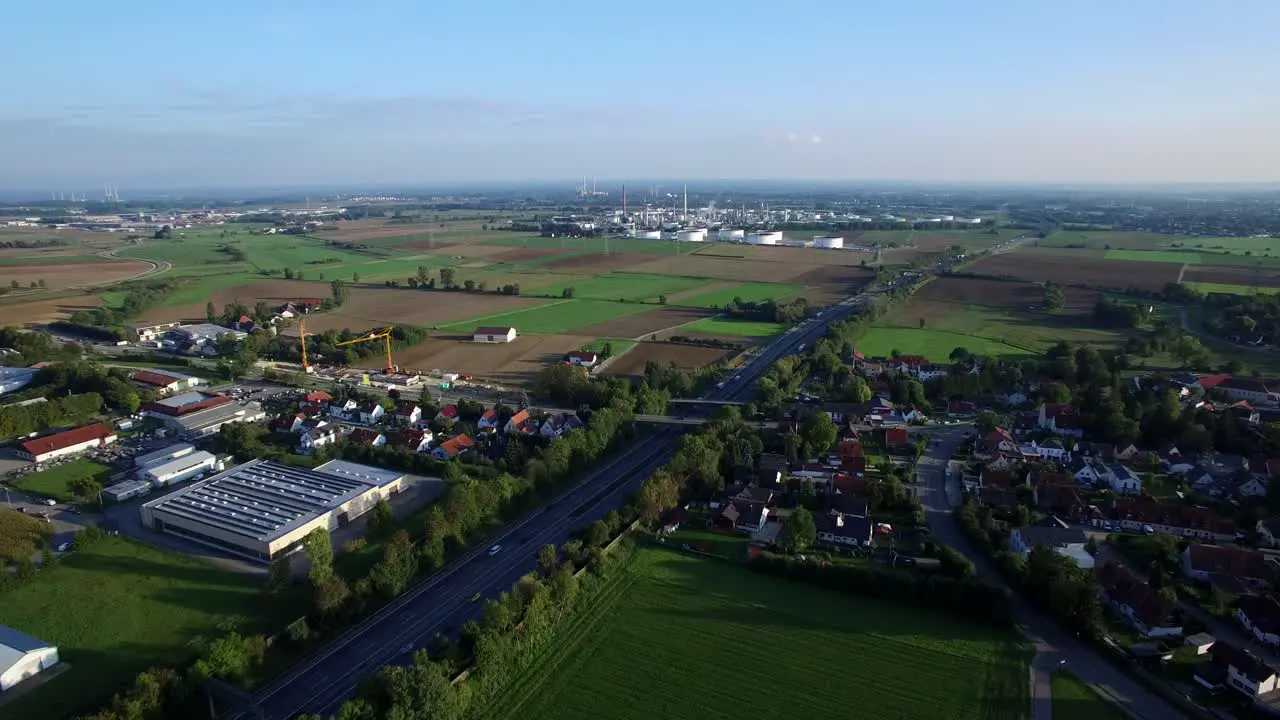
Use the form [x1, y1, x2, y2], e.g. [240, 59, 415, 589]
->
[0, 0, 1280, 190]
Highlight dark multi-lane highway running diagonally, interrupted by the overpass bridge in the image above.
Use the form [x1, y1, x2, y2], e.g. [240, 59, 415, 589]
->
[238, 278, 876, 720]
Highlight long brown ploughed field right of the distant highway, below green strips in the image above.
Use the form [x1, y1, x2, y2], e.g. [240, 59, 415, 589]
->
[969, 249, 1180, 290]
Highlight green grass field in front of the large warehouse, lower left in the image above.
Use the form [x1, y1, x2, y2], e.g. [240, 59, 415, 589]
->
[0, 537, 279, 720]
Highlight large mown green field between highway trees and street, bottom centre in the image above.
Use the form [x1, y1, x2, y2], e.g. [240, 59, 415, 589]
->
[484, 547, 1029, 720]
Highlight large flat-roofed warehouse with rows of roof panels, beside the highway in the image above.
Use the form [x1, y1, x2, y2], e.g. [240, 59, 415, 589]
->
[140, 460, 404, 561]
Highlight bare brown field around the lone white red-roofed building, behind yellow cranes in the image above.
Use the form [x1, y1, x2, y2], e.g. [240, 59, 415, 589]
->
[373, 328, 595, 384]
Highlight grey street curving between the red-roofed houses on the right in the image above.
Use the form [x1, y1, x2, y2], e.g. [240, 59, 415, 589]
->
[916, 425, 1184, 720]
